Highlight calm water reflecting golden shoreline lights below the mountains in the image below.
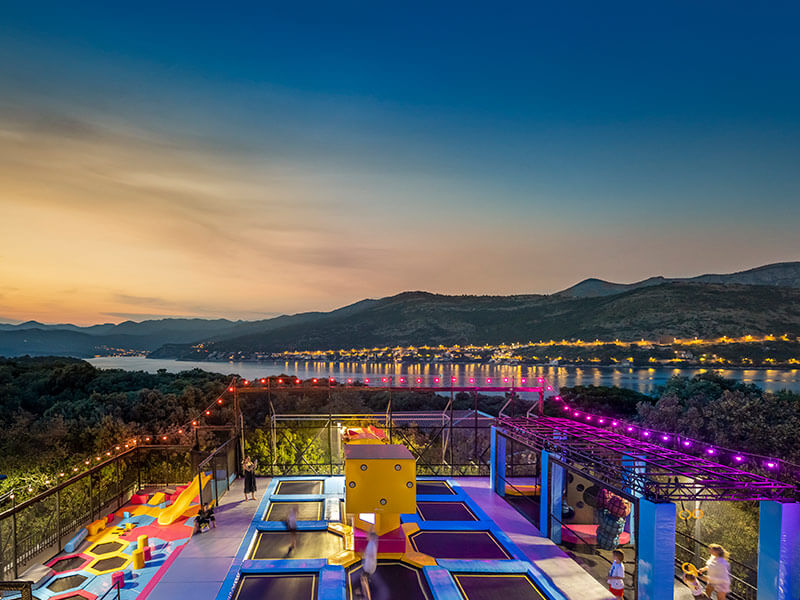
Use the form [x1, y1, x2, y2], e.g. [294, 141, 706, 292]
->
[89, 357, 800, 394]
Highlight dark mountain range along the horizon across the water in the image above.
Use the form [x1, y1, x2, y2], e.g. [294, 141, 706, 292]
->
[0, 262, 800, 359]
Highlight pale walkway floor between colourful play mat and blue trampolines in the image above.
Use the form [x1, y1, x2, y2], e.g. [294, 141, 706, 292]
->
[142, 477, 270, 600]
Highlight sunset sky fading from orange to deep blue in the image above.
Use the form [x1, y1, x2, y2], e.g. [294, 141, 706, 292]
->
[0, 0, 800, 324]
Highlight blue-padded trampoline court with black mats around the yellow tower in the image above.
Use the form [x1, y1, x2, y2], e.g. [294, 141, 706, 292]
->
[212, 476, 564, 600]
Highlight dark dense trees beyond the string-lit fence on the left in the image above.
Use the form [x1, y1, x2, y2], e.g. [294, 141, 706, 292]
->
[0, 357, 230, 493]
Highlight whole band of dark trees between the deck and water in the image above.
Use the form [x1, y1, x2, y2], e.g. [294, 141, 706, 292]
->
[0, 357, 800, 502]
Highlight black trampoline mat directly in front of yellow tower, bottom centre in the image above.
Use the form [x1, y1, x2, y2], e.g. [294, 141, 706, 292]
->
[347, 561, 433, 600]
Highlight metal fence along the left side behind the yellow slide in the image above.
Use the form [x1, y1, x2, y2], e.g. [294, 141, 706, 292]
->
[0, 437, 238, 581]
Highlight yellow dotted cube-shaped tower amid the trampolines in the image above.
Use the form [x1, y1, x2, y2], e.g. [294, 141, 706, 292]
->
[344, 444, 417, 535]
